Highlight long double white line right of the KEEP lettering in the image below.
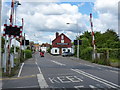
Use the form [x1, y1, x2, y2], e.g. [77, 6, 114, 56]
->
[72, 69, 120, 88]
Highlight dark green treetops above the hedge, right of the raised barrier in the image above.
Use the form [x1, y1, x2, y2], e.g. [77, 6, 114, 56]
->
[95, 29, 120, 48]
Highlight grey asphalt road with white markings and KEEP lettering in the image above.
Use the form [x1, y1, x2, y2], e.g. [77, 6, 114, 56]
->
[2, 53, 120, 90]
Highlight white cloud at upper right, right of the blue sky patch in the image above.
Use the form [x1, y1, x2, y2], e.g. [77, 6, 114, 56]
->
[93, 0, 119, 33]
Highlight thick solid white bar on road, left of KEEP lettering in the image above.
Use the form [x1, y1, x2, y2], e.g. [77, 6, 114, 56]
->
[37, 74, 48, 88]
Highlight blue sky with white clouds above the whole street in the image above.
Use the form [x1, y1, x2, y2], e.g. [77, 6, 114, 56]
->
[2, 0, 119, 44]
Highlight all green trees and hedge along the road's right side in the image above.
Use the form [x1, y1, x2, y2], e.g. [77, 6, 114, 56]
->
[75, 29, 120, 65]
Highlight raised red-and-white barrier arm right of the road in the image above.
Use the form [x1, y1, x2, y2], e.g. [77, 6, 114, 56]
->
[90, 13, 96, 60]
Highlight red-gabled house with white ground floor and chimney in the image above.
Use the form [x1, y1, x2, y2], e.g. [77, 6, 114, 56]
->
[51, 32, 74, 55]
